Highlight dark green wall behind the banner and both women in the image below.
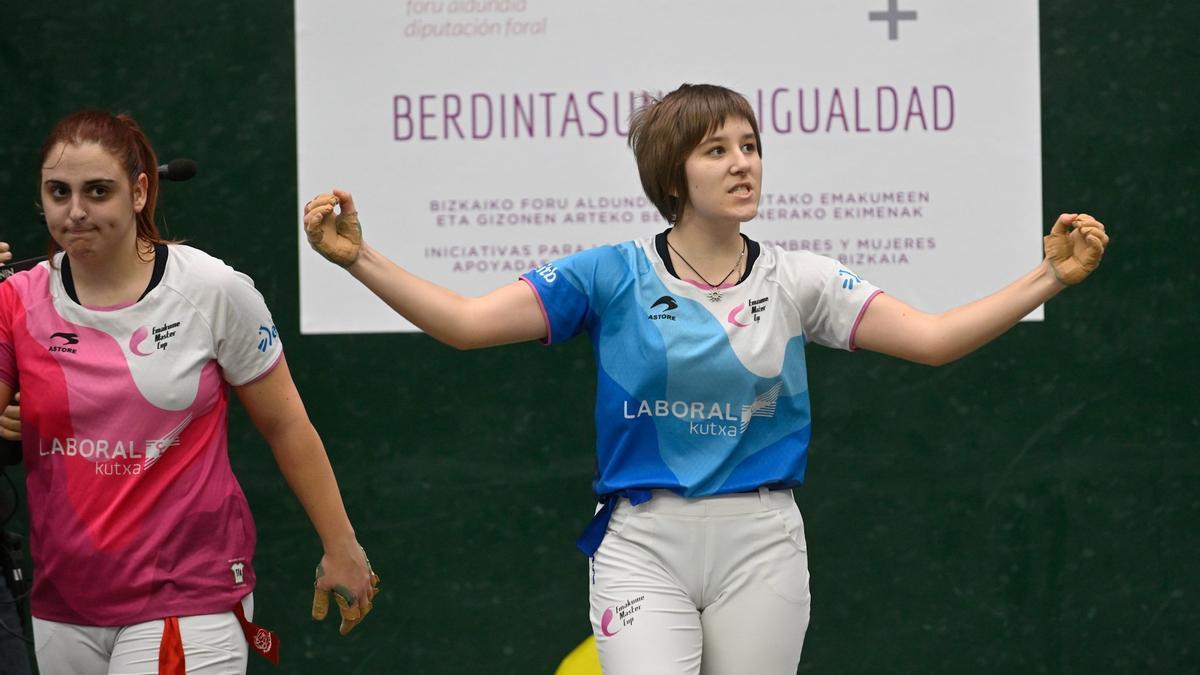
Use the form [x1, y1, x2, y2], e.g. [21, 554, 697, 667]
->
[0, 0, 1200, 674]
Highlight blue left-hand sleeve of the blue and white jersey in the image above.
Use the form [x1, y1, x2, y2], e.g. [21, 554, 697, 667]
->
[521, 246, 619, 345]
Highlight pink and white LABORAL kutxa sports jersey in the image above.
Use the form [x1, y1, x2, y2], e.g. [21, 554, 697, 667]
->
[0, 245, 282, 626]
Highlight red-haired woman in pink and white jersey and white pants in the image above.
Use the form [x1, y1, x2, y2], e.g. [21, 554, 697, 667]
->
[0, 110, 378, 675]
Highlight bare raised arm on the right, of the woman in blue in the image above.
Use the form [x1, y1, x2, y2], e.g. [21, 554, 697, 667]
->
[854, 214, 1109, 365]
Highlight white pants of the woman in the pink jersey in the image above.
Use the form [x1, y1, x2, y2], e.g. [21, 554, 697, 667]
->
[34, 593, 254, 675]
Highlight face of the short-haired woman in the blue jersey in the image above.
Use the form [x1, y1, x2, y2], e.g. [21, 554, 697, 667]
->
[679, 118, 762, 223]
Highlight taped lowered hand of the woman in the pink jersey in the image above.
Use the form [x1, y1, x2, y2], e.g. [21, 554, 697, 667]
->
[312, 542, 379, 635]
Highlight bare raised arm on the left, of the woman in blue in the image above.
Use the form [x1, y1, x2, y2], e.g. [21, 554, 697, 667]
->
[304, 190, 546, 350]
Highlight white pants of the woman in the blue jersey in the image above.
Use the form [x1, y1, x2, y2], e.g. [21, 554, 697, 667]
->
[588, 490, 809, 675]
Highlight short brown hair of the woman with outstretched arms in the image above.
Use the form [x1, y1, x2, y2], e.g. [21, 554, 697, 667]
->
[629, 84, 762, 223]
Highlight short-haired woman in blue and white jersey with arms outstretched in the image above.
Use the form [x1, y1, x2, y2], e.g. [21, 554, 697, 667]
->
[304, 84, 1108, 675]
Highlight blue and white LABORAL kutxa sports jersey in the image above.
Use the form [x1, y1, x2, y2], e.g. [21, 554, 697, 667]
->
[522, 235, 878, 506]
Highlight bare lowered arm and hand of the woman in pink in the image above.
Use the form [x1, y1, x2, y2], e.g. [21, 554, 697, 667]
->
[236, 356, 378, 634]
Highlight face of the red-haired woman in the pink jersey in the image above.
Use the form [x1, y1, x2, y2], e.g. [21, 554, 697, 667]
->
[42, 143, 146, 258]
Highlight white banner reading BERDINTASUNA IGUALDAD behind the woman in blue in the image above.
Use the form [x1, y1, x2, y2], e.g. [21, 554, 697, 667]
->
[295, 0, 1045, 333]
